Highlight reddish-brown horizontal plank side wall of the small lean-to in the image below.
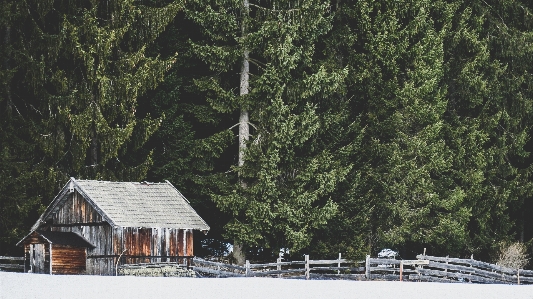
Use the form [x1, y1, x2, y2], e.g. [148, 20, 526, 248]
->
[52, 245, 87, 274]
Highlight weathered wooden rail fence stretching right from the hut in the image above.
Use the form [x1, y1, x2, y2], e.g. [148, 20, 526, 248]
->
[192, 254, 533, 284]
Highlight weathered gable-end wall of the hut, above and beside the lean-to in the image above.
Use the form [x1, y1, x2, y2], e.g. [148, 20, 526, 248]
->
[51, 192, 114, 275]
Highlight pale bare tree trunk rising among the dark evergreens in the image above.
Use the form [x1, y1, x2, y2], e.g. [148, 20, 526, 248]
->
[233, 0, 250, 266]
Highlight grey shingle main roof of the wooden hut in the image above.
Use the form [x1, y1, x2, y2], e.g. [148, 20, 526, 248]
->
[32, 178, 209, 231]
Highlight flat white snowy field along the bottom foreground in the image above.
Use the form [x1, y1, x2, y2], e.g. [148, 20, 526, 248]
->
[0, 272, 533, 299]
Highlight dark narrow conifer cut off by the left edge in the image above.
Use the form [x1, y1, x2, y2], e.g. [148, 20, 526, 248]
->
[0, 1, 40, 255]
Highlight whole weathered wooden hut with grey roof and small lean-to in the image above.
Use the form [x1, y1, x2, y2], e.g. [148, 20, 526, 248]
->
[17, 178, 209, 275]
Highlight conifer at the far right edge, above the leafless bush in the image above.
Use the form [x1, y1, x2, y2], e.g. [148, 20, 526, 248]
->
[446, 1, 532, 256]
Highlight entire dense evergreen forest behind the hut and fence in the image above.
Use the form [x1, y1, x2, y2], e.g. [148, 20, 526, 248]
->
[0, 0, 533, 263]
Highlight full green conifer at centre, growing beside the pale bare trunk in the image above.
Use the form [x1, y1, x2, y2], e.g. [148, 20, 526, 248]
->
[189, 1, 349, 262]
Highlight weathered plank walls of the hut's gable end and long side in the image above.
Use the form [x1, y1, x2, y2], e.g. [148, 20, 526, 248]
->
[40, 191, 193, 275]
